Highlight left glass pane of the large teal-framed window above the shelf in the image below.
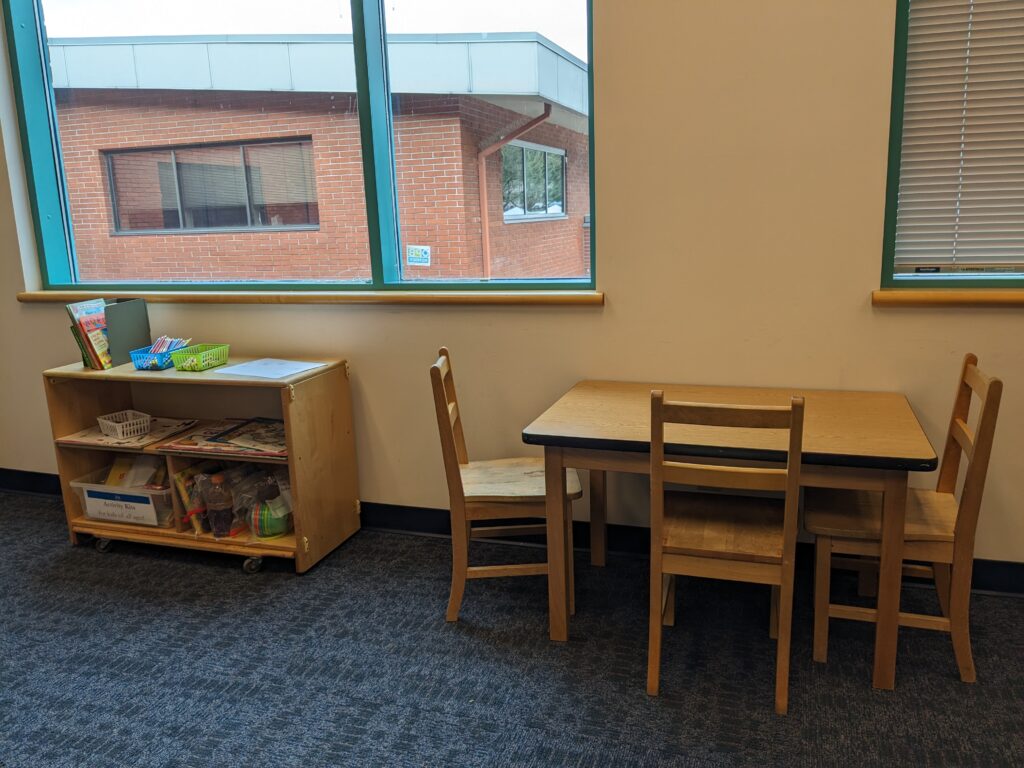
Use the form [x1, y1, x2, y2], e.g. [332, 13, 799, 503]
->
[42, 0, 371, 283]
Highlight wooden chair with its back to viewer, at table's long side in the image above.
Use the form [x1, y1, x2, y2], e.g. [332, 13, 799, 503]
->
[647, 390, 804, 715]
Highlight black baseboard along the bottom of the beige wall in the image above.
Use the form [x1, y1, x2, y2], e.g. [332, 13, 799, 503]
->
[0, 468, 1024, 594]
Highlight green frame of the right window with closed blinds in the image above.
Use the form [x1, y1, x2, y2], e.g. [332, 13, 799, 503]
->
[881, 0, 1024, 290]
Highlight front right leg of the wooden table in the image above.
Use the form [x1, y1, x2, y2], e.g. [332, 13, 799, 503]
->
[872, 472, 906, 690]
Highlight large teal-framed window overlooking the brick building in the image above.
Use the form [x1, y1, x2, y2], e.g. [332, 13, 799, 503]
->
[0, 0, 594, 291]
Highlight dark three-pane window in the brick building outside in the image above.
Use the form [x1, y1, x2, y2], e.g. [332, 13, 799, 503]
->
[105, 139, 319, 233]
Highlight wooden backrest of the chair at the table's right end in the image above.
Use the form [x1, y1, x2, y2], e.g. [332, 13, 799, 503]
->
[935, 353, 1002, 556]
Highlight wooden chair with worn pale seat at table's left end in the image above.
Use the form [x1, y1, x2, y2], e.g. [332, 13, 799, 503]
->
[430, 347, 583, 622]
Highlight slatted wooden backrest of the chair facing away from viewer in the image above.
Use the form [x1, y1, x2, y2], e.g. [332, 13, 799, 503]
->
[650, 397, 804, 564]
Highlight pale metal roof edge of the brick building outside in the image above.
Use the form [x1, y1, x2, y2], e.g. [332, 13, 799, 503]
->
[48, 33, 589, 115]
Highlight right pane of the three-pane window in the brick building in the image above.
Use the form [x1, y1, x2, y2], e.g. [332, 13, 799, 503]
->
[246, 141, 319, 226]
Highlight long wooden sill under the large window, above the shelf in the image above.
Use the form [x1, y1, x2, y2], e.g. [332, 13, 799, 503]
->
[17, 290, 604, 306]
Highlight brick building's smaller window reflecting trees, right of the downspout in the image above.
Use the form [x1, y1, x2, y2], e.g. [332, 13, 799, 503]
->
[502, 141, 565, 221]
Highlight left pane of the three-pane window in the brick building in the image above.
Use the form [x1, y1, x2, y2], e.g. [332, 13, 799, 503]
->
[108, 152, 181, 231]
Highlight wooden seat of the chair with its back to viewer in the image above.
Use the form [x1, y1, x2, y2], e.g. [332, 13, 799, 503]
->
[662, 493, 784, 563]
